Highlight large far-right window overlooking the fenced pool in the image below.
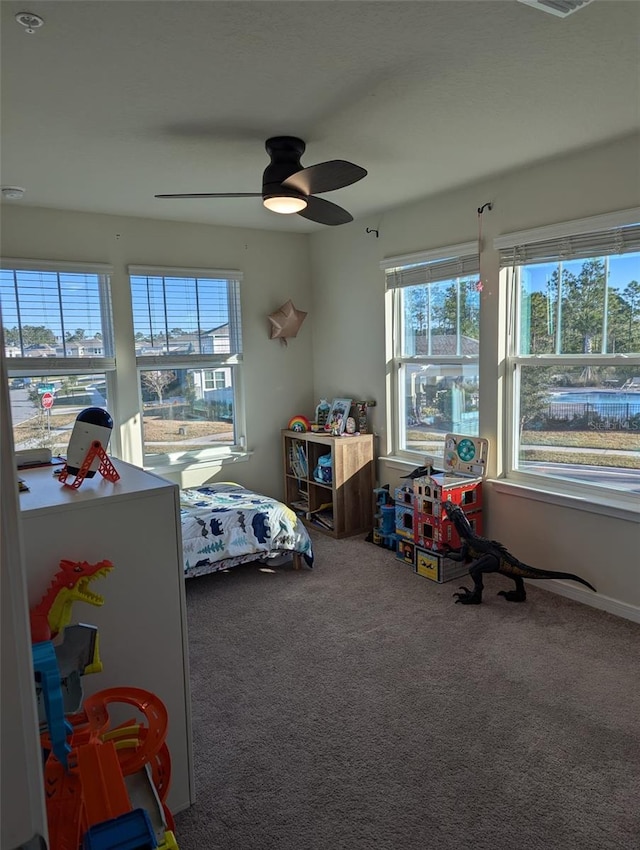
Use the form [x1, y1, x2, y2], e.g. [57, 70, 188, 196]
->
[495, 210, 640, 498]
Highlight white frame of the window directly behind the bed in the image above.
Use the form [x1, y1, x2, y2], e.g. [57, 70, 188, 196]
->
[128, 265, 247, 470]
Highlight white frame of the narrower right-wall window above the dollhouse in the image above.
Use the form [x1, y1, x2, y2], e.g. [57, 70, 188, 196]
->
[380, 241, 480, 465]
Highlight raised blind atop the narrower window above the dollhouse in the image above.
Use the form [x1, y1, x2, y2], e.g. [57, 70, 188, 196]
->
[380, 242, 480, 289]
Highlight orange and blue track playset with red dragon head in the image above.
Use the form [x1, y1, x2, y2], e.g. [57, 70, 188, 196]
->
[30, 560, 178, 850]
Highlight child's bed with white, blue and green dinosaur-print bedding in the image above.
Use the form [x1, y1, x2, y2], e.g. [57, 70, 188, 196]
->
[180, 482, 313, 578]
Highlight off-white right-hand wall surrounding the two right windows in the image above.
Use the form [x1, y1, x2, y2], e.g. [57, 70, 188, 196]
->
[311, 136, 640, 621]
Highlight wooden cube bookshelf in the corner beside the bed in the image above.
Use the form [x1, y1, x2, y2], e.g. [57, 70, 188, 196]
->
[282, 430, 375, 538]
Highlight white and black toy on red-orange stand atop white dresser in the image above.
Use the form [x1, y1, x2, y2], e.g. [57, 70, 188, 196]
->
[58, 407, 120, 490]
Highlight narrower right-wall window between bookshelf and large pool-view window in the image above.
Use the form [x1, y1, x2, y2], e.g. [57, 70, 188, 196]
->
[381, 242, 481, 460]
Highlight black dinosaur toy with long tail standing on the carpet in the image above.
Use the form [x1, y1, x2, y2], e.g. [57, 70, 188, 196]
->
[442, 501, 597, 605]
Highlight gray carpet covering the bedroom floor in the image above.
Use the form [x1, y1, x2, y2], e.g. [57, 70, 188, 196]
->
[176, 533, 640, 850]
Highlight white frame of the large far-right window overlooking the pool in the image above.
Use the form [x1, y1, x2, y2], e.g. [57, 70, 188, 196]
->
[494, 207, 640, 516]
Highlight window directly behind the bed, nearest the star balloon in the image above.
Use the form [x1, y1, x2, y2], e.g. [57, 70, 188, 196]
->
[129, 266, 245, 466]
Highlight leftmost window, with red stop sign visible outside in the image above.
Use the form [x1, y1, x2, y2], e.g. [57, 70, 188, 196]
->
[0, 259, 115, 455]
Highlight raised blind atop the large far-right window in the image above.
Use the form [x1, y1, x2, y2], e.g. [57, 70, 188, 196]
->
[494, 211, 640, 268]
